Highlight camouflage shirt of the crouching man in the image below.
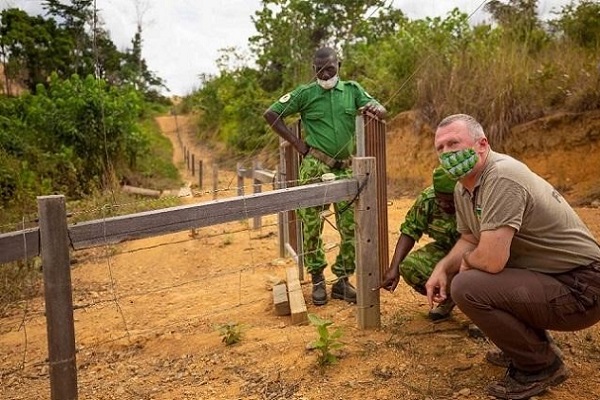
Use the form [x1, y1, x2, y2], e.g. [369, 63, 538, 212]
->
[400, 186, 460, 250]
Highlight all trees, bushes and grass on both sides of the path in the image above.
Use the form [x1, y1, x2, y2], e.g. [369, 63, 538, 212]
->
[0, 0, 600, 304]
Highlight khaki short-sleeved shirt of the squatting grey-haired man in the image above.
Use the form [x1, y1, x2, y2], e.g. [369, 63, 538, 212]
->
[454, 151, 600, 273]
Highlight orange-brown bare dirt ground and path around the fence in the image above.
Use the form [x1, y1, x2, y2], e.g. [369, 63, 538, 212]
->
[0, 116, 600, 400]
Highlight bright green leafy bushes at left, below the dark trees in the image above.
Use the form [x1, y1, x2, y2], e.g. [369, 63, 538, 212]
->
[0, 75, 154, 212]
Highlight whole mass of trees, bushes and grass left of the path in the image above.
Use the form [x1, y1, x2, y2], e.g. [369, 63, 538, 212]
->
[0, 0, 178, 223]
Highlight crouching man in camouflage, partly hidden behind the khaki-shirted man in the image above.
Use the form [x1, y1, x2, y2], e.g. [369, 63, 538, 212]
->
[381, 167, 460, 321]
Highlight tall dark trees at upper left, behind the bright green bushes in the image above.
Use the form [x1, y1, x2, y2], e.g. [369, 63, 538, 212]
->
[0, 0, 163, 98]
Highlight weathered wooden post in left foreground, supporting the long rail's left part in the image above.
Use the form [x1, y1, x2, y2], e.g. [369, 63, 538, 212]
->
[38, 196, 77, 400]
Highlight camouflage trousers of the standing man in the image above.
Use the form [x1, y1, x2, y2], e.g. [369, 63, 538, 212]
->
[298, 156, 355, 277]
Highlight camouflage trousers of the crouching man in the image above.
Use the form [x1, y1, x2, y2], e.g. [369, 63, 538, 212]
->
[400, 242, 450, 294]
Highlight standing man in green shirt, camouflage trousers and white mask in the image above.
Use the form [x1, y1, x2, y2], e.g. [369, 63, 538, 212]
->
[264, 47, 386, 305]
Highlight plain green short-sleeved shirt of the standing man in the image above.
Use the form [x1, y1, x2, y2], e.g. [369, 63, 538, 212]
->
[270, 80, 375, 160]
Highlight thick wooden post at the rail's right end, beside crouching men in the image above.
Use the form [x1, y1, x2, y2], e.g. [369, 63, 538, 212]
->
[352, 157, 381, 329]
